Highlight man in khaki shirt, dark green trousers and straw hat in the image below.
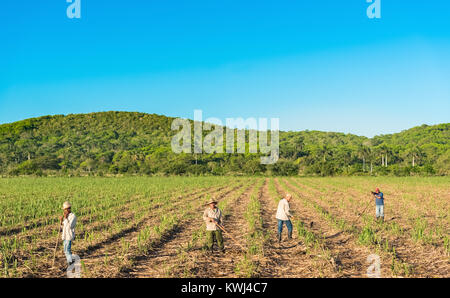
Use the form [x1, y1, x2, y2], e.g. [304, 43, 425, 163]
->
[203, 200, 225, 253]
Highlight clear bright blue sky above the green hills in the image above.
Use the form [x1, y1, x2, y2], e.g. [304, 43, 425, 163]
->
[0, 0, 450, 136]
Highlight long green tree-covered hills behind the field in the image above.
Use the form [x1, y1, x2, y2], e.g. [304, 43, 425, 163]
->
[0, 112, 450, 175]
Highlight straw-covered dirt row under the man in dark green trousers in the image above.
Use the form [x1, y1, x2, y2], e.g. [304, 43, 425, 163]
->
[129, 186, 253, 278]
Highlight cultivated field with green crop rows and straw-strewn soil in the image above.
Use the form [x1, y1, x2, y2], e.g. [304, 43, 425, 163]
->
[0, 177, 450, 277]
